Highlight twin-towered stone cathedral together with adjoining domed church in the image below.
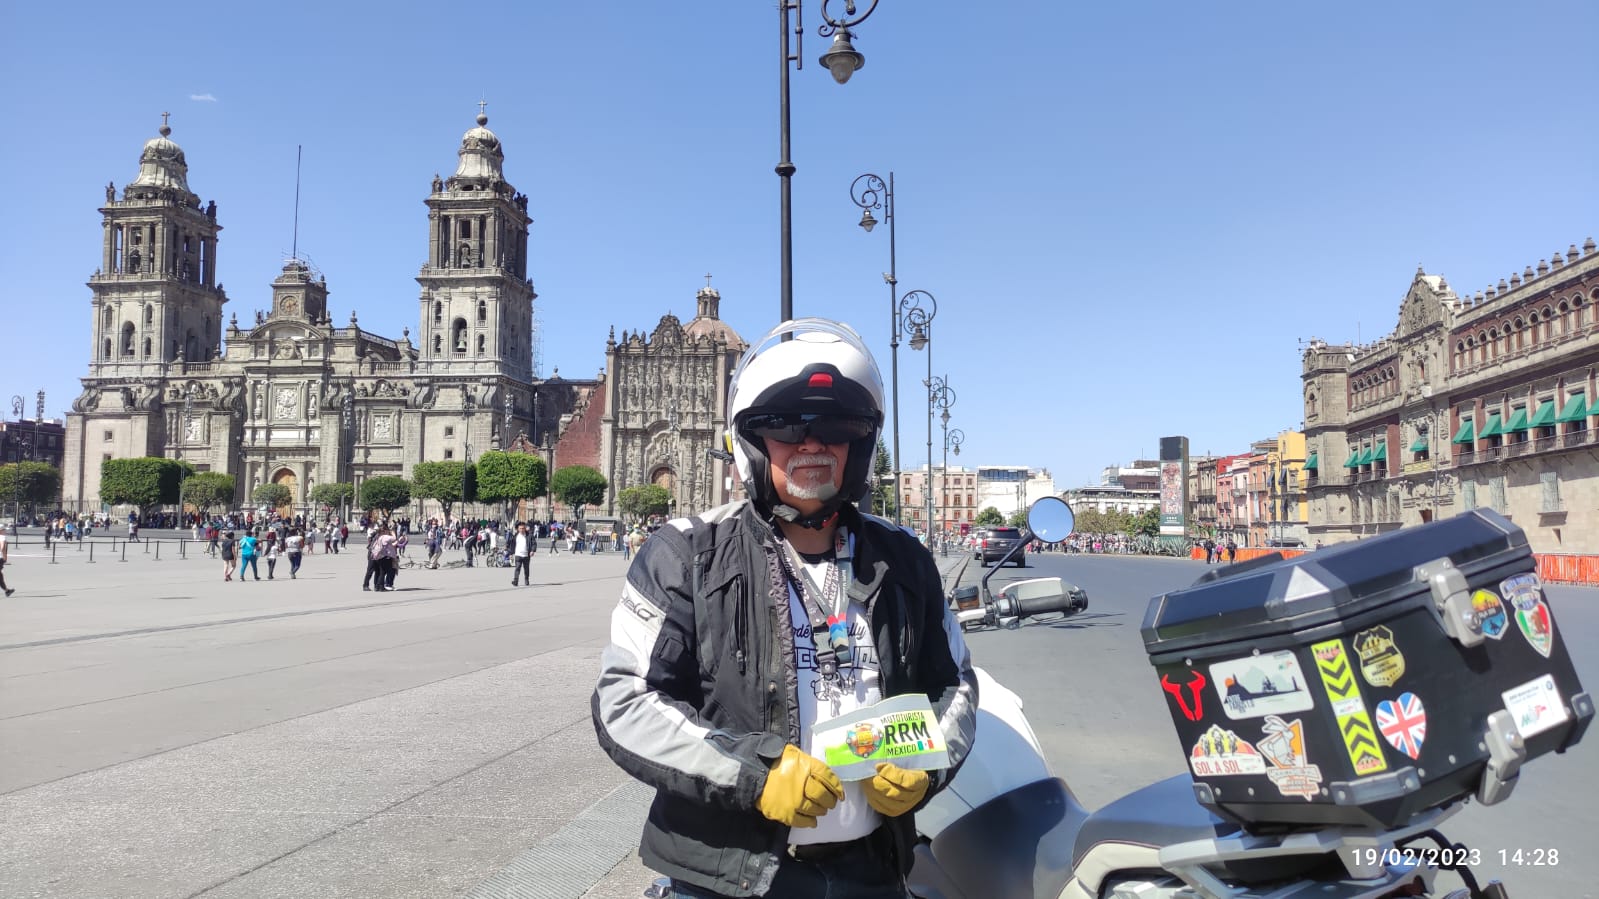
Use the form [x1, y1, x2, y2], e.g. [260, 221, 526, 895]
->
[62, 112, 745, 515]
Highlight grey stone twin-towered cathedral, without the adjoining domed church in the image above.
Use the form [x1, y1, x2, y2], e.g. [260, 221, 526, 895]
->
[62, 114, 556, 509]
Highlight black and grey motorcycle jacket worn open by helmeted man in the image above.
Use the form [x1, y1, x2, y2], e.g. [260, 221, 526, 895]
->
[592, 502, 977, 896]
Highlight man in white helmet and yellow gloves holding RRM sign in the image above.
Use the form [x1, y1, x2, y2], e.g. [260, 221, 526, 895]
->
[592, 318, 977, 899]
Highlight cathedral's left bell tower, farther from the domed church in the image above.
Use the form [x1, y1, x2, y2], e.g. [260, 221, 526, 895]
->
[88, 112, 227, 369]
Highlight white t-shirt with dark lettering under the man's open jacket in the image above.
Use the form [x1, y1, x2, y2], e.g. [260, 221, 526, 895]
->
[788, 550, 883, 845]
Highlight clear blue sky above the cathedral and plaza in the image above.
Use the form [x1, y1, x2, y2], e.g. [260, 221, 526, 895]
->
[0, 0, 1599, 488]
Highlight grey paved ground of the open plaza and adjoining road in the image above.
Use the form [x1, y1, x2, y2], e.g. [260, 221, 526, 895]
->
[0, 534, 1599, 899]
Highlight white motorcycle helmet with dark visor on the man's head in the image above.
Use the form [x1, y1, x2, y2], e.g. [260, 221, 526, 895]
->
[728, 318, 883, 528]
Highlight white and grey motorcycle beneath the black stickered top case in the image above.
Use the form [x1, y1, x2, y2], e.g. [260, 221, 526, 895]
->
[908, 497, 1508, 899]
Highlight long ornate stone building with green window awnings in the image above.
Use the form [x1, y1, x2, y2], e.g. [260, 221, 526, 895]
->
[1303, 238, 1599, 553]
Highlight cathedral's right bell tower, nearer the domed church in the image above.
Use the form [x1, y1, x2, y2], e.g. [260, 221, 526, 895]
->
[416, 106, 536, 374]
